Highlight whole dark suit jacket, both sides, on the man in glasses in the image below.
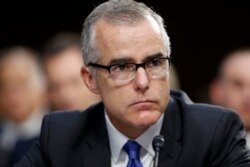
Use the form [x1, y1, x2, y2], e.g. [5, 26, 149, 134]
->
[15, 91, 250, 167]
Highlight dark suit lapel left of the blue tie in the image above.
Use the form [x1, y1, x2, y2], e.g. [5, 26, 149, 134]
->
[82, 105, 111, 167]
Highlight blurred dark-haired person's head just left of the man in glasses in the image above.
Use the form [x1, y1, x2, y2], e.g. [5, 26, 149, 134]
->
[43, 32, 100, 111]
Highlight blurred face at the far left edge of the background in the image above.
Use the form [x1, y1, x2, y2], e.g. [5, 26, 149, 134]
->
[0, 55, 41, 122]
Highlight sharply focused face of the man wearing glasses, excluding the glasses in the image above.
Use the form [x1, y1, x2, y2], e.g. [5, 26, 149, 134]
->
[86, 20, 169, 138]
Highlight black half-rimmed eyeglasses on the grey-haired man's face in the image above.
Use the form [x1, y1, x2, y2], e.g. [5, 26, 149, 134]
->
[88, 57, 171, 85]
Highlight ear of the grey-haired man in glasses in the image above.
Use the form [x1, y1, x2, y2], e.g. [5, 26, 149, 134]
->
[81, 66, 99, 95]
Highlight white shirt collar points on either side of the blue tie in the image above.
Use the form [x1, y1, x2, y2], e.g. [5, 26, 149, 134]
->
[105, 111, 164, 162]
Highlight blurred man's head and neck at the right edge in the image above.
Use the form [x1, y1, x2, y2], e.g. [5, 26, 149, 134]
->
[210, 48, 250, 146]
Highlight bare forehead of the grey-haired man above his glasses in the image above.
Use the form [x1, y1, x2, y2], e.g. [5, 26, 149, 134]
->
[96, 19, 165, 63]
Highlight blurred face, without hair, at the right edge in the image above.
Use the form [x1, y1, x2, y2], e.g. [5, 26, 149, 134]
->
[222, 52, 250, 129]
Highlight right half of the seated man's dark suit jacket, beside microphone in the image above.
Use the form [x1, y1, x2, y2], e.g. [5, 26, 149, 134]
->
[160, 91, 250, 167]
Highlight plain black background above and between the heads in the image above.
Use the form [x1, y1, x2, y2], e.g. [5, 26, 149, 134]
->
[0, 0, 250, 102]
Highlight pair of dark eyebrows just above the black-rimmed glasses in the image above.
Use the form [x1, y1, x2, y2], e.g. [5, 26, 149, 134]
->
[109, 52, 165, 65]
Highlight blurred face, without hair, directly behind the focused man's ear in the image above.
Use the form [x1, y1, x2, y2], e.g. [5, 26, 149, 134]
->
[45, 47, 99, 110]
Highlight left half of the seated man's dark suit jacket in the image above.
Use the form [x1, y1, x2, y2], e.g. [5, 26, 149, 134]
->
[14, 103, 110, 167]
